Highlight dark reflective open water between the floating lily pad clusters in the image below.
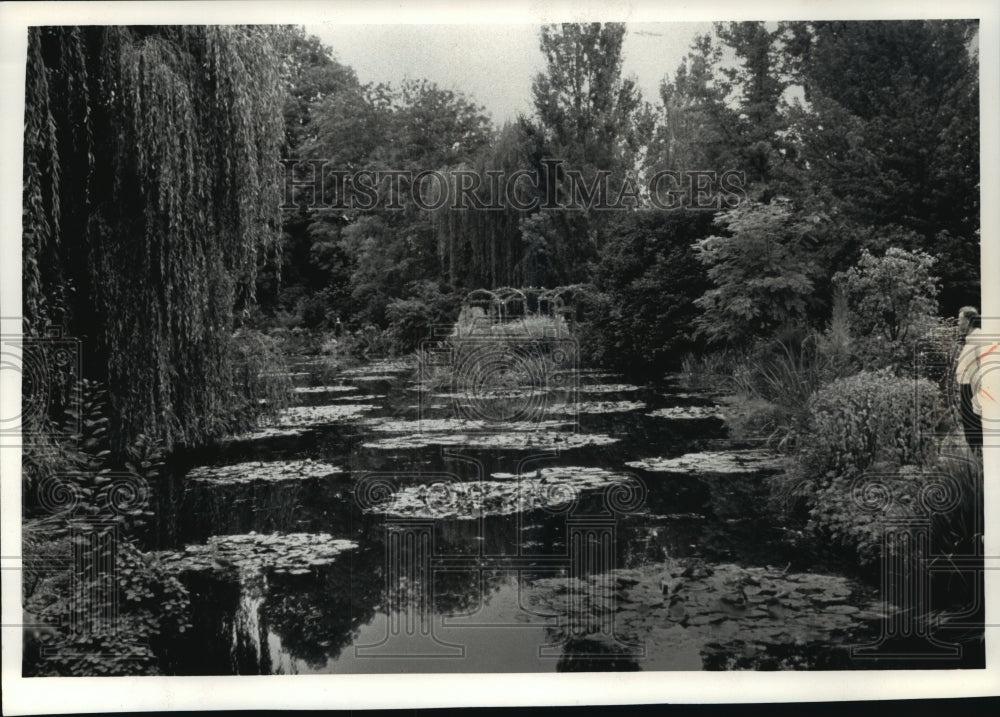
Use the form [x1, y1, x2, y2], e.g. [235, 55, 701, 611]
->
[147, 366, 924, 674]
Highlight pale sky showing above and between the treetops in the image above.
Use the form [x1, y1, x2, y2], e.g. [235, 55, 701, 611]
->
[306, 22, 712, 125]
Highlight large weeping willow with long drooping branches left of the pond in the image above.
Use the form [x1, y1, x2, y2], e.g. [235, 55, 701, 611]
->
[23, 26, 284, 445]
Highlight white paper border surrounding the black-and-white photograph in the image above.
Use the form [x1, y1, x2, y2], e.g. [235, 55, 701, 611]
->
[0, 0, 1000, 714]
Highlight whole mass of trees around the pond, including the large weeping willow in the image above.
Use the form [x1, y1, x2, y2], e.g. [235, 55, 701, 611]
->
[24, 21, 979, 442]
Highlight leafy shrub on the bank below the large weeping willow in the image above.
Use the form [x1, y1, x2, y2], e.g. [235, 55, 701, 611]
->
[22, 380, 189, 675]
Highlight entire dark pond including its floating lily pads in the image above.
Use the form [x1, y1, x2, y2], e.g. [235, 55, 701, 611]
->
[139, 361, 968, 675]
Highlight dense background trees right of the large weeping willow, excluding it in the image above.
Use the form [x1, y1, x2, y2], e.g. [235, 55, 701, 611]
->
[260, 21, 979, 365]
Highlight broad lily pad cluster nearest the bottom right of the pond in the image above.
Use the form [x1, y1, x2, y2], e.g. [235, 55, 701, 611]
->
[521, 561, 885, 669]
